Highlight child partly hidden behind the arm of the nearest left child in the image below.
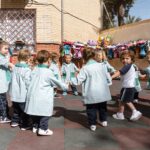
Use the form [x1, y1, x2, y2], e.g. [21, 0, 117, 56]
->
[50, 52, 61, 98]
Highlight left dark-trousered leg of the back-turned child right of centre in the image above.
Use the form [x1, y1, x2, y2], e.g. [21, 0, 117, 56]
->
[86, 104, 97, 126]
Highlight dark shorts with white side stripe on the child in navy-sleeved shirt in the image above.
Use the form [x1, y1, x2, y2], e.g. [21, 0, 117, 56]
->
[120, 88, 136, 102]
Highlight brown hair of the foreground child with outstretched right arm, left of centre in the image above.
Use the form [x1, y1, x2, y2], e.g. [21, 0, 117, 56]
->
[36, 50, 51, 64]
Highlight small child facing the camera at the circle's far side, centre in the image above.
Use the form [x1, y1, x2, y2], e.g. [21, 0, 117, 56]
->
[61, 54, 79, 96]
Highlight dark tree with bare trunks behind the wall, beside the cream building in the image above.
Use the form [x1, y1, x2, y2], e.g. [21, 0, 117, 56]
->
[103, 0, 135, 29]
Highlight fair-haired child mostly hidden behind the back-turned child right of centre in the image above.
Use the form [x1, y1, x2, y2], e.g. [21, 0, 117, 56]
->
[95, 50, 116, 85]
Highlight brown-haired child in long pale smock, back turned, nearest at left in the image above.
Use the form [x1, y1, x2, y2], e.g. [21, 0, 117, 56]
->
[25, 50, 68, 135]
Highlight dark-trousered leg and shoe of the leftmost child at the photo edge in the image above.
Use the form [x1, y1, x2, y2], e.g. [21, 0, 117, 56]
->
[0, 93, 11, 123]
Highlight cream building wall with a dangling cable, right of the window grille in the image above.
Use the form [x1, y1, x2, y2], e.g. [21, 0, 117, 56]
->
[0, 0, 101, 43]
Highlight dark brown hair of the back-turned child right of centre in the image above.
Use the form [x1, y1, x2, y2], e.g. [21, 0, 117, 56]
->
[83, 48, 95, 62]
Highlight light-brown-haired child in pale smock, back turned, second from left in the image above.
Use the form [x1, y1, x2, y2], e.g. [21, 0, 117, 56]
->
[9, 50, 31, 130]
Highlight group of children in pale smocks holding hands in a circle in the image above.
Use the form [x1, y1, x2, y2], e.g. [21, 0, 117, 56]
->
[0, 41, 150, 135]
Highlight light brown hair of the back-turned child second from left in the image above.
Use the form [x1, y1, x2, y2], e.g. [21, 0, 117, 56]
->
[18, 49, 31, 61]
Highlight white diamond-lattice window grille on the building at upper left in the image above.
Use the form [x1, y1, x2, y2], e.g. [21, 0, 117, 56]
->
[0, 9, 36, 51]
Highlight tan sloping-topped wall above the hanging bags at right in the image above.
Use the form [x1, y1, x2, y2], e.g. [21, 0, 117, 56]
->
[100, 20, 150, 43]
